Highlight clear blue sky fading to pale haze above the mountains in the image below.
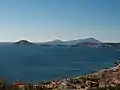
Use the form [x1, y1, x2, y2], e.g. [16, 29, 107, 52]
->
[0, 0, 120, 42]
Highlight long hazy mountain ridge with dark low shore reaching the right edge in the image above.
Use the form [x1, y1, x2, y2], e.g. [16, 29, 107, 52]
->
[42, 38, 120, 48]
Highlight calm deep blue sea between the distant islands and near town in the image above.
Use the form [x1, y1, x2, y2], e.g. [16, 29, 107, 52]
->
[0, 44, 120, 82]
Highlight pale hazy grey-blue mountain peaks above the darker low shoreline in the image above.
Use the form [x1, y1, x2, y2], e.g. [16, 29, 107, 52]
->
[43, 38, 101, 46]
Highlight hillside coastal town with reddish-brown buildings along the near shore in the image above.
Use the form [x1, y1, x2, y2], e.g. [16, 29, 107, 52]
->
[0, 62, 120, 90]
